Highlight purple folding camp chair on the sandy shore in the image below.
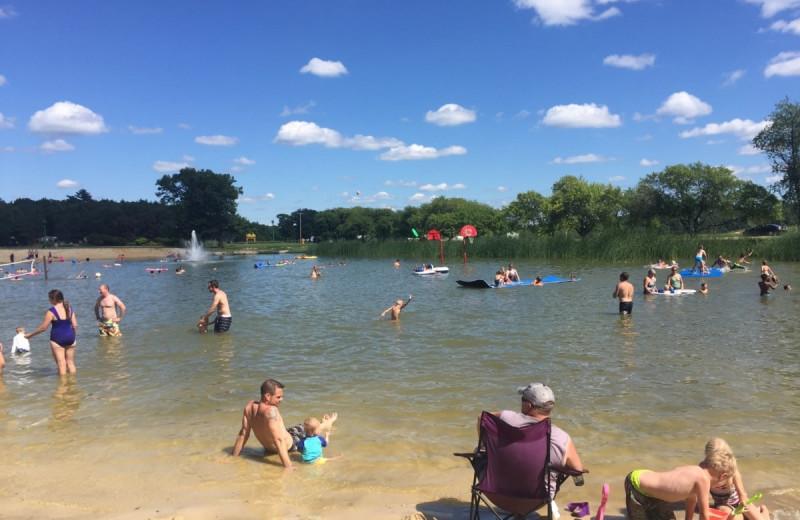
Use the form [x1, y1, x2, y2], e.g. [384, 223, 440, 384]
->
[454, 412, 586, 520]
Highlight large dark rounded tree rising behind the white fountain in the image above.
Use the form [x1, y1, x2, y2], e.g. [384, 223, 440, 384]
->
[156, 168, 244, 242]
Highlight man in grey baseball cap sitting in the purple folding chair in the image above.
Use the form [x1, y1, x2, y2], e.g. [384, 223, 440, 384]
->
[484, 383, 583, 498]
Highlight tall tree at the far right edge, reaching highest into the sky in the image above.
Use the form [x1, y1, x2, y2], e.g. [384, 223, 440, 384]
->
[753, 97, 800, 220]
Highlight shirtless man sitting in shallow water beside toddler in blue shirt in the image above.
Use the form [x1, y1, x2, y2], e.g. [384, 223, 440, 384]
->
[231, 379, 338, 470]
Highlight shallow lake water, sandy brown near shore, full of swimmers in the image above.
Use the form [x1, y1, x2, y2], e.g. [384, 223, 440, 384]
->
[0, 256, 800, 519]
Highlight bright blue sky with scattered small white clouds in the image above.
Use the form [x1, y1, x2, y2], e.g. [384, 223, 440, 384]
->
[0, 0, 800, 224]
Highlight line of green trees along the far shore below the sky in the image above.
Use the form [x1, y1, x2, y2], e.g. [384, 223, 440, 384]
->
[0, 98, 800, 245]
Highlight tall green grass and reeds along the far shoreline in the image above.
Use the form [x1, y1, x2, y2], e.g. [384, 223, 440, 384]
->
[313, 231, 800, 263]
